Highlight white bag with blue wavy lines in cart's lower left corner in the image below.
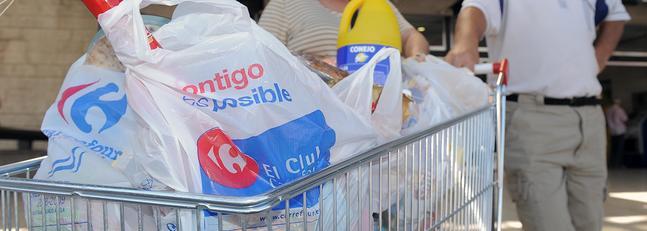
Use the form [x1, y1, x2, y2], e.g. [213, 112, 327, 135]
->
[29, 136, 163, 230]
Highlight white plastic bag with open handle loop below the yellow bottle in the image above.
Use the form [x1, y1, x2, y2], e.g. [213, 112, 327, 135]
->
[333, 48, 402, 142]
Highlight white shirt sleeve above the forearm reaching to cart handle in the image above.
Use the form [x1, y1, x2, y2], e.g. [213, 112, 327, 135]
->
[461, 0, 504, 35]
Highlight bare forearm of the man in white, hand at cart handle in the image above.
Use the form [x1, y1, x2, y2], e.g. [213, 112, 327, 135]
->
[445, 7, 487, 70]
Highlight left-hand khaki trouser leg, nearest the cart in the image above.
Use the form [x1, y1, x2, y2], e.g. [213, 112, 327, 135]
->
[505, 97, 581, 231]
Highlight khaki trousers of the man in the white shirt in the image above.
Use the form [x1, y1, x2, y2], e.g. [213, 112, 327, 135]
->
[505, 95, 607, 231]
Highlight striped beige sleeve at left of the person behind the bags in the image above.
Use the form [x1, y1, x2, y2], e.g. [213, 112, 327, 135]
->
[258, 0, 288, 45]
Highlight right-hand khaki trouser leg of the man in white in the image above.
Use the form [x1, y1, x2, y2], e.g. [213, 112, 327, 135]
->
[566, 107, 607, 231]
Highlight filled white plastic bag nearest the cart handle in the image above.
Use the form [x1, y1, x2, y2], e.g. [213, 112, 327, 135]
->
[383, 55, 493, 228]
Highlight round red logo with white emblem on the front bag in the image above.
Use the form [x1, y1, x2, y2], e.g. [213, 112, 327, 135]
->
[198, 128, 258, 188]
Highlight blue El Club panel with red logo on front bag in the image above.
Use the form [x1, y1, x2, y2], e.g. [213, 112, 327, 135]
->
[197, 110, 335, 209]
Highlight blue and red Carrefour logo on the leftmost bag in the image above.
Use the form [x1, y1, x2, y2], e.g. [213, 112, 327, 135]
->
[57, 81, 128, 133]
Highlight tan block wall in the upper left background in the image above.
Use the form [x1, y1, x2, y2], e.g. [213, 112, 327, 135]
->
[0, 0, 97, 129]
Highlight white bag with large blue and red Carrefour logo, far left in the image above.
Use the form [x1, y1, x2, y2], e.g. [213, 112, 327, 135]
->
[37, 55, 137, 177]
